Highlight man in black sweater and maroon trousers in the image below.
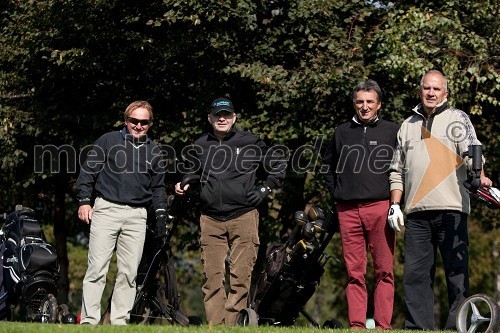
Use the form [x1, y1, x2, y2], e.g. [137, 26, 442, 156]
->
[322, 80, 398, 329]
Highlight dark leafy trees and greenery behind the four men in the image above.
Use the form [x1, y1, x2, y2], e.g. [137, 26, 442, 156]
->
[0, 0, 500, 327]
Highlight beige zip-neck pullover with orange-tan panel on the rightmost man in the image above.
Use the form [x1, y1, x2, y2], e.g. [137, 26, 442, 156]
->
[389, 101, 480, 214]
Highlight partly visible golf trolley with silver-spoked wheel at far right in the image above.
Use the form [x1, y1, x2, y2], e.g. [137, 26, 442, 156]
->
[457, 145, 500, 333]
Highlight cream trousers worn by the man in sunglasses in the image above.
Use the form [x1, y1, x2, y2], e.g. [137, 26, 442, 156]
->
[81, 198, 147, 325]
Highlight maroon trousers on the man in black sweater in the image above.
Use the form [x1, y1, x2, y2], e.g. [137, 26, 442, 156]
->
[337, 200, 396, 329]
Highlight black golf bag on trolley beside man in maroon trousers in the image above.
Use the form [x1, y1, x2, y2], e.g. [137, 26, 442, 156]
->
[236, 202, 342, 328]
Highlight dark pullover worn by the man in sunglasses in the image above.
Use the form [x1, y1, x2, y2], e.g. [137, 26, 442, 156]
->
[77, 128, 167, 209]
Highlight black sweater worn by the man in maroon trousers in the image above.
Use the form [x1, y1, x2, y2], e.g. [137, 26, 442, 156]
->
[321, 118, 399, 201]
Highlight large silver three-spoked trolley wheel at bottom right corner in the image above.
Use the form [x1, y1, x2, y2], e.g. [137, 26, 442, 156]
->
[457, 294, 500, 333]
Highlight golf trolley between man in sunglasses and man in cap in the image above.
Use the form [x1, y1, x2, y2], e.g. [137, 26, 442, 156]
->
[101, 175, 201, 326]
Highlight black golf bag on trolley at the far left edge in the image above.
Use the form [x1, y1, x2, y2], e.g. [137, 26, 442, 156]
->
[0, 205, 76, 323]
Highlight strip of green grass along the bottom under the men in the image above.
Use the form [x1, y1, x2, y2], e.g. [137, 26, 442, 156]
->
[0, 322, 456, 333]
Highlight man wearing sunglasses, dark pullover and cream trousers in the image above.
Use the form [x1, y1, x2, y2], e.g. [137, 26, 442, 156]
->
[77, 101, 166, 325]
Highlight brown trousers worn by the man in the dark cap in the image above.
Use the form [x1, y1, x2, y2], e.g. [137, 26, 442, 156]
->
[200, 210, 259, 325]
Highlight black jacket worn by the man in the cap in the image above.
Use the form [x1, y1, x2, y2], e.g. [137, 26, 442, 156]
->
[186, 131, 287, 221]
